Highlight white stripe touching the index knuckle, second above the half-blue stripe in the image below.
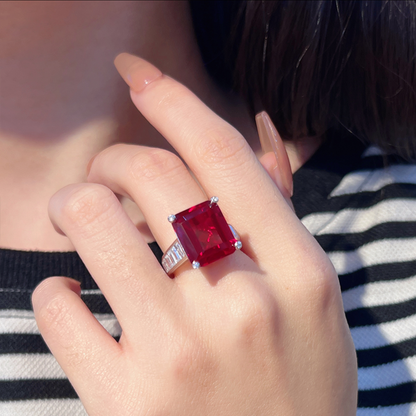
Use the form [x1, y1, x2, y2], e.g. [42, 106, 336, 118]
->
[328, 238, 416, 275]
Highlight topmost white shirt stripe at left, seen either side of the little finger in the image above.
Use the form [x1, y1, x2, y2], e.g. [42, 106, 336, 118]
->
[0, 309, 121, 337]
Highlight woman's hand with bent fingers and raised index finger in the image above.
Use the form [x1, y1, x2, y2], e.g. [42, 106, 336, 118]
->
[33, 54, 357, 416]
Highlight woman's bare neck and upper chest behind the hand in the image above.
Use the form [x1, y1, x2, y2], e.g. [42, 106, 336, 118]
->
[0, 1, 258, 251]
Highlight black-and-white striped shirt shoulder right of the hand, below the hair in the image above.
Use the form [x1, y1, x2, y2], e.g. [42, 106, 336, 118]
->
[294, 141, 416, 416]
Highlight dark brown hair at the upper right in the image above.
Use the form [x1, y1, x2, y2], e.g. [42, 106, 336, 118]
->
[191, 0, 416, 159]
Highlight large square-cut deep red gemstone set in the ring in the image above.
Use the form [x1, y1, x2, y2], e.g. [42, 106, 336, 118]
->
[172, 201, 237, 266]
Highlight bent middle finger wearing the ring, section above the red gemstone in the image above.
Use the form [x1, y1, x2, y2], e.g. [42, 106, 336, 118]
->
[88, 144, 208, 252]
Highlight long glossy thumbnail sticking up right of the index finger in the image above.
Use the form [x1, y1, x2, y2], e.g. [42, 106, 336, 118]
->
[256, 111, 293, 196]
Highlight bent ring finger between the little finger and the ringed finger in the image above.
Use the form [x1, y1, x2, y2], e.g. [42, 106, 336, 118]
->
[49, 184, 174, 333]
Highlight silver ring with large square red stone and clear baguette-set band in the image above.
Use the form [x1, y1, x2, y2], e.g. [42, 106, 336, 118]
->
[162, 196, 243, 274]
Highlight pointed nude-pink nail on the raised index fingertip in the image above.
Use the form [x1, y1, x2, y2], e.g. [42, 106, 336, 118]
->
[114, 52, 162, 92]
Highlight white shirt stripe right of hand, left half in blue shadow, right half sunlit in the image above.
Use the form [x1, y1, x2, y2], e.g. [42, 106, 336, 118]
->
[351, 315, 416, 350]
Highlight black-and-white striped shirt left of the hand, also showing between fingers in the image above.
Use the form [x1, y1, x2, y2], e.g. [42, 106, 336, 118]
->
[0, 288, 121, 416]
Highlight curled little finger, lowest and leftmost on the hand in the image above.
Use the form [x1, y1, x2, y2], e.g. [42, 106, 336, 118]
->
[32, 277, 121, 405]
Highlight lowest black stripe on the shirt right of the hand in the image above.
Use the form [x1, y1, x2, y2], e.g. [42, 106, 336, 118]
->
[358, 382, 416, 407]
